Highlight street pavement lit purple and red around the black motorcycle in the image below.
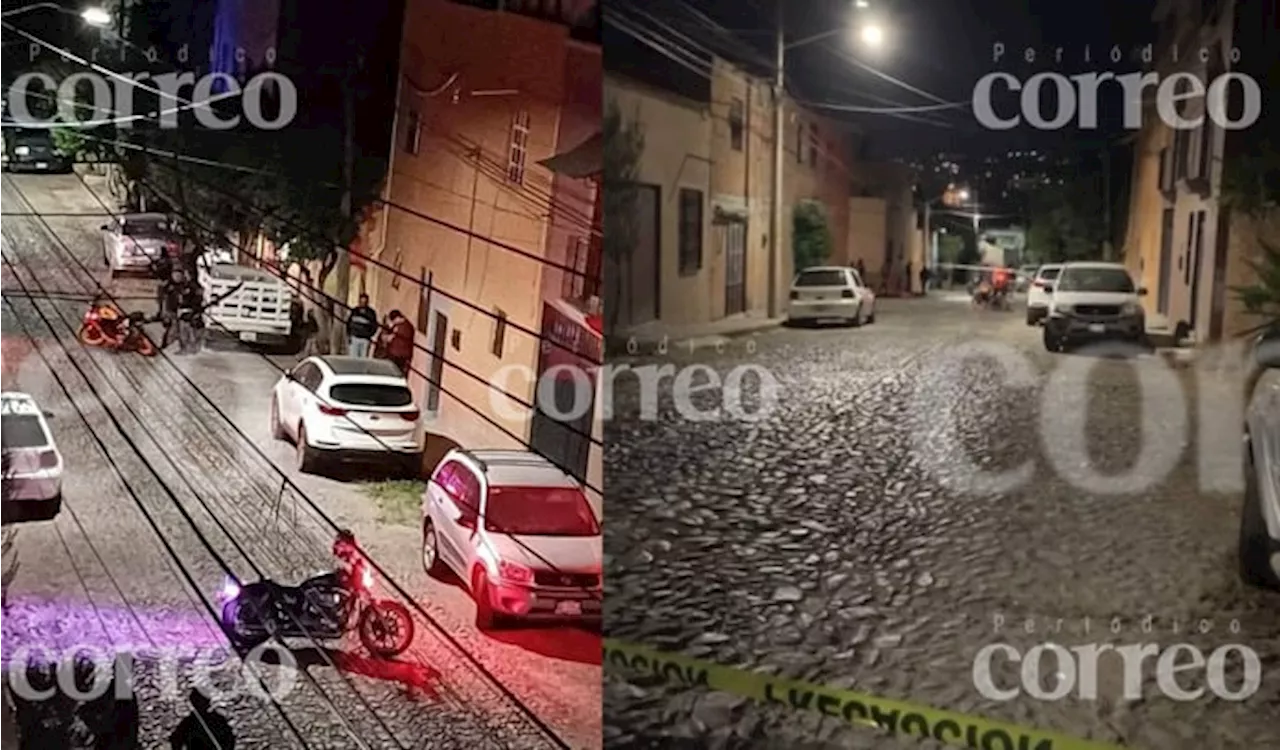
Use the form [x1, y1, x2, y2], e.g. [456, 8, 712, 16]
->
[0, 175, 600, 749]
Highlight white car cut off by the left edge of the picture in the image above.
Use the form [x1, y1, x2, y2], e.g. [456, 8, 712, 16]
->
[0, 392, 63, 520]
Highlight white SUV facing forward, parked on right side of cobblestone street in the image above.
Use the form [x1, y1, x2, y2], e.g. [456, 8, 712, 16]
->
[1044, 262, 1147, 352]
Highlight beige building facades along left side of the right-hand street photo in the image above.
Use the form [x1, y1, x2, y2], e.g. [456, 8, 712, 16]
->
[605, 58, 858, 333]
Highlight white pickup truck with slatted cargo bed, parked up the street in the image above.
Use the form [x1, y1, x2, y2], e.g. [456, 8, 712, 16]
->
[200, 257, 293, 346]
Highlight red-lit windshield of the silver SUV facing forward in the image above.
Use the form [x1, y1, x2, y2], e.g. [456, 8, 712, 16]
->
[484, 486, 600, 536]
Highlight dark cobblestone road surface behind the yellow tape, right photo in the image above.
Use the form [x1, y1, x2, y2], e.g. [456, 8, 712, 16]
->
[605, 298, 1280, 750]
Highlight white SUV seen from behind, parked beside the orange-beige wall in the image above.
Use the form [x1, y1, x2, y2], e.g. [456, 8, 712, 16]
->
[271, 357, 425, 476]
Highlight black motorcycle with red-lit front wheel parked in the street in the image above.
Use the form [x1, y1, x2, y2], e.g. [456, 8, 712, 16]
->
[223, 568, 415, 659]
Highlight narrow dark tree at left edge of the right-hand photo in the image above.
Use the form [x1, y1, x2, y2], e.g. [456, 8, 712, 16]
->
[602, 99, 644, 329]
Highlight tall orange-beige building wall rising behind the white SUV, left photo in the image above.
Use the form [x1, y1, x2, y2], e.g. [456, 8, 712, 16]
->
[366, 0, 567, 448]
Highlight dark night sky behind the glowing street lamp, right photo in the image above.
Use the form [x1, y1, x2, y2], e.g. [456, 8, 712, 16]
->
[618, 0, 1155, 157]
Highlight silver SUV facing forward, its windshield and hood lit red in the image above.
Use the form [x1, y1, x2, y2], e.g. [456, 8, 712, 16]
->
[422, 449, 604, 627]
